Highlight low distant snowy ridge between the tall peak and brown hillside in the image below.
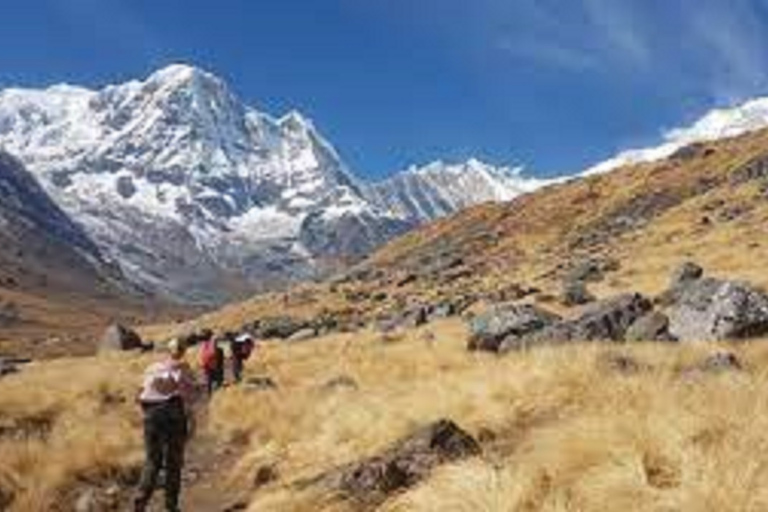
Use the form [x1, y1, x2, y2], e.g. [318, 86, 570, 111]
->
[366, 159, 548, 223]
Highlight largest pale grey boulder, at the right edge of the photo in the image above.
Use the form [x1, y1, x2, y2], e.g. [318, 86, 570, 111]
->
[668, 278, 768, 341]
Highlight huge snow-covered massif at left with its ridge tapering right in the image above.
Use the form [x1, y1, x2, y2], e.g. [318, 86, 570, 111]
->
[0, 65, 532, 301]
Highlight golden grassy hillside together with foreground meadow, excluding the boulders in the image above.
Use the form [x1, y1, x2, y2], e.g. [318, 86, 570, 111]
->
[7, 132, 768, 512]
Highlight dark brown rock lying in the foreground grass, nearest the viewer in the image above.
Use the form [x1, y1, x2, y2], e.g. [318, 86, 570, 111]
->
[318, 419, 480, 505]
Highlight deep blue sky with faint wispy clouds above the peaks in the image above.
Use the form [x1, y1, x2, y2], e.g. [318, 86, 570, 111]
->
[0, 0, 768, 180]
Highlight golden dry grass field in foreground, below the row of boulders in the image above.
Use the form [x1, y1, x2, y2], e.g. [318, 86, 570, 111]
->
[0, 321, 768, 512]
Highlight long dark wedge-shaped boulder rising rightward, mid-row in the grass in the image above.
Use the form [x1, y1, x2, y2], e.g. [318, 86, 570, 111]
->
[516, 293, 652, 351]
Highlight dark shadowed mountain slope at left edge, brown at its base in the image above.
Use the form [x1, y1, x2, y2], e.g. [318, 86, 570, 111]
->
[0, 152, 184, 358]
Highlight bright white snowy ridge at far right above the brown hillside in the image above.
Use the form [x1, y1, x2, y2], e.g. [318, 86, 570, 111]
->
[582, 98, 768, 176]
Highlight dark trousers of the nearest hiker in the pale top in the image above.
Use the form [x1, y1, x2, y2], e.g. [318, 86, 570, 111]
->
[136, 398, 187, 512]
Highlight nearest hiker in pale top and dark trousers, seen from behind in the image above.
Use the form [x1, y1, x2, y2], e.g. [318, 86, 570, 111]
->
[134, 340, 197, 512]
